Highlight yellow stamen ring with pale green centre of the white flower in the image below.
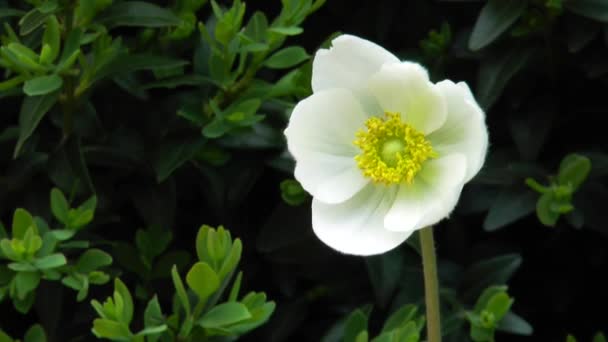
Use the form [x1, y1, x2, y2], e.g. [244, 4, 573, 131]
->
[354, 112, 437, 185]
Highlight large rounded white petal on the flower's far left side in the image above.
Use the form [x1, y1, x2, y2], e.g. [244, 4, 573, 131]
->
[285, 89, 368, 203]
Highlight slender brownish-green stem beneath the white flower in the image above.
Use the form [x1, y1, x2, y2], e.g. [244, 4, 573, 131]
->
[420, 226, 441, 342]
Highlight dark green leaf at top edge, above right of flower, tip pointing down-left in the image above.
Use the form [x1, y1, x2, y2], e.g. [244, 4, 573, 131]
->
[469, 0, 527, 51]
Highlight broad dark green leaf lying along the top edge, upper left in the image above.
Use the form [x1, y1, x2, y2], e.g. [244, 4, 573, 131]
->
[96, 1, 181, 28]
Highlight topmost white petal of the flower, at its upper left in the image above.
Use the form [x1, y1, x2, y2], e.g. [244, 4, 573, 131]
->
[312, 35, 399, 115]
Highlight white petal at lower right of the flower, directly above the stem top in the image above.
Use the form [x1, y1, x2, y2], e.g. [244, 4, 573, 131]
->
[384, 154, 466, 231]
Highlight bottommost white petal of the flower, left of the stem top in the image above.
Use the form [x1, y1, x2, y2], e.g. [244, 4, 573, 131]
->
[312, 184, 411, 255]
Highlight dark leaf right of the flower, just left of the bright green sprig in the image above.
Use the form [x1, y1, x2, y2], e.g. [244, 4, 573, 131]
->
[483, 187, 536, 232]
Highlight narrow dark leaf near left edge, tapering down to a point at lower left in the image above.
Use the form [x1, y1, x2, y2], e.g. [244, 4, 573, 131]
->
[13, 92, 59, 158]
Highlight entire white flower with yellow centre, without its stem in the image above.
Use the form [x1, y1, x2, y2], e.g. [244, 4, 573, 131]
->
[285, 35, 488, 255]
